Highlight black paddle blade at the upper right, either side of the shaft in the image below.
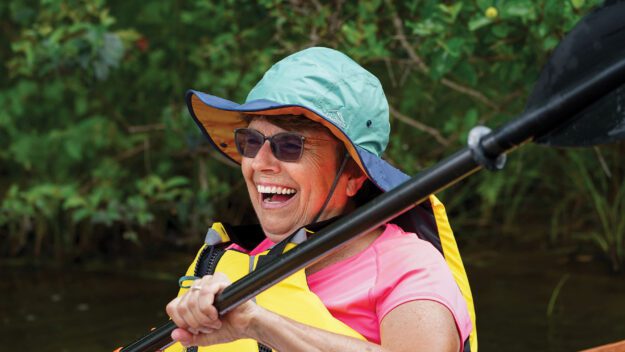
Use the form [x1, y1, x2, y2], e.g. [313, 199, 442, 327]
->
[526, 1, 625, 147]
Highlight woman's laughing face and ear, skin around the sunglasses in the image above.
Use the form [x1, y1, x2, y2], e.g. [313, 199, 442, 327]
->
[241, 119, 362, 242]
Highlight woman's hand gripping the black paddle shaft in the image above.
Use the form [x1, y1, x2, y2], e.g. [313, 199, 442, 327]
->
[166, 273, 260, 346]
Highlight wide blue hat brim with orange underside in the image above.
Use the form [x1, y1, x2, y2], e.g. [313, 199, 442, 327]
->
[186, 90, 409, 192]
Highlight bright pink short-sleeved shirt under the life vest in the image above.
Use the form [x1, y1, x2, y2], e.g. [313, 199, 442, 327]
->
[236, 224, 472, 344]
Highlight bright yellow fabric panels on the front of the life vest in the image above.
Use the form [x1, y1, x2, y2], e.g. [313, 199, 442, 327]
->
[164, 223, 365, 352]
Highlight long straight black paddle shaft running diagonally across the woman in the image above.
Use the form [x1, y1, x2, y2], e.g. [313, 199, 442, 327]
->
[122, 53, 625, 352]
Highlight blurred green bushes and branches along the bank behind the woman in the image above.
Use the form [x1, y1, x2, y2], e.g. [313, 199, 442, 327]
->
[0, 0, 625, 271]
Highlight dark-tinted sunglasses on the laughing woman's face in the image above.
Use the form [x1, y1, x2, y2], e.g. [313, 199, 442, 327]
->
[234, 128, 305, 162]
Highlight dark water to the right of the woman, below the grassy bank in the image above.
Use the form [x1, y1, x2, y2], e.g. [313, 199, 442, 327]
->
[464, 246, 625, 351]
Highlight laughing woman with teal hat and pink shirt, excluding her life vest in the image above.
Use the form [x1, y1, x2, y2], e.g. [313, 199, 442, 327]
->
[167, 48, 475, 351]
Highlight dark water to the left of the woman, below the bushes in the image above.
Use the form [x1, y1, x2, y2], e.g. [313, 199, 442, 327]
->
[0, 260, 177, 352]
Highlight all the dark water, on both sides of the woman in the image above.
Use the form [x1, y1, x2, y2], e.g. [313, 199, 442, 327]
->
[0, 250, 625, 352]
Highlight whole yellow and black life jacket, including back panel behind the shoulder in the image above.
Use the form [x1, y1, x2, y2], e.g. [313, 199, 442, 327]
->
[165, 195, 477, 352]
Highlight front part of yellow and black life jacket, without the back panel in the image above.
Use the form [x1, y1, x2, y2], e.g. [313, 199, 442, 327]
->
[164, 223, 365, 352]
